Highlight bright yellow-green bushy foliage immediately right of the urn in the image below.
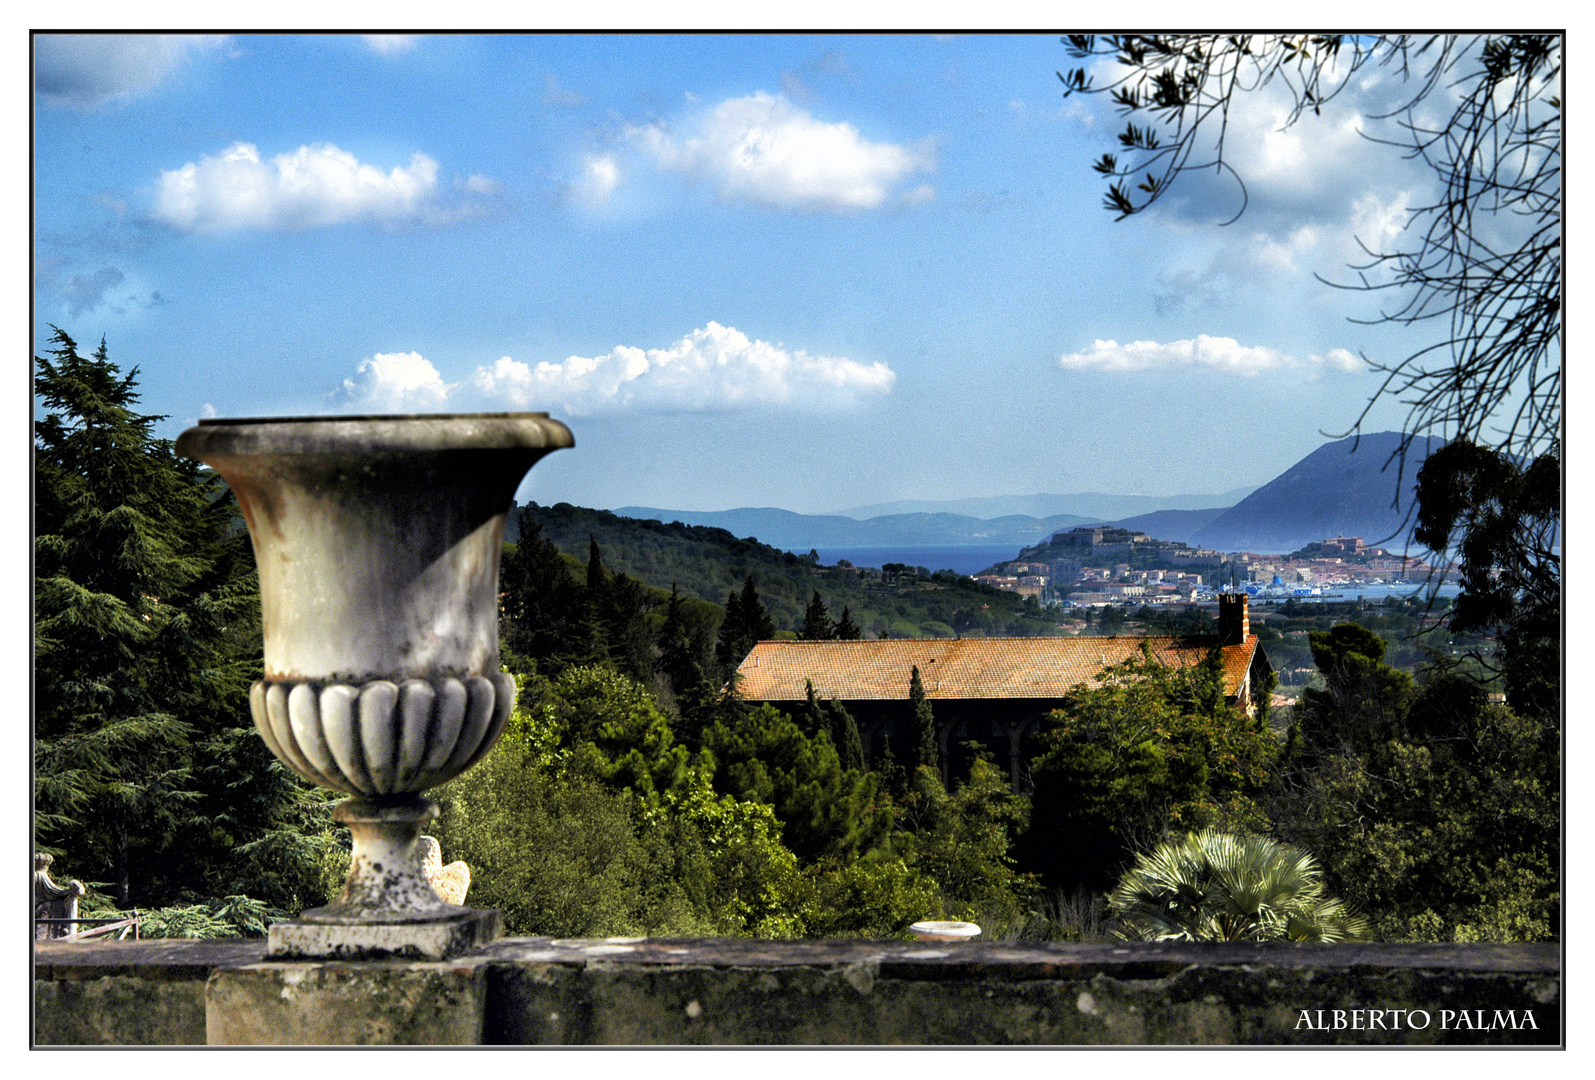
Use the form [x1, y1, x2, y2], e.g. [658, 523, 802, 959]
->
[434, 668, 801, 936]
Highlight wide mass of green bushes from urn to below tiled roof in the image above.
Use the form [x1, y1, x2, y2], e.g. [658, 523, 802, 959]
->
[434, 667, 1029, 936]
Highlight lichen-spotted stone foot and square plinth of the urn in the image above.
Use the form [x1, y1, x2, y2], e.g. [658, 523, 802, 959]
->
[266, 794, 504, 960]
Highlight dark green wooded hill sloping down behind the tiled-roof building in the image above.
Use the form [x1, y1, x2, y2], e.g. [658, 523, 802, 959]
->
[506, 503, 1057, 638]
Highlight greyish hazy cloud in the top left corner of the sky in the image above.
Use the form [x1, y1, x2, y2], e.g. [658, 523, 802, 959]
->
[33, 34, 226, 108]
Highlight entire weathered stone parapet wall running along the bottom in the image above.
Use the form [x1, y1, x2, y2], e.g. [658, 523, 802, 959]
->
[35, 938, 1563, 1045]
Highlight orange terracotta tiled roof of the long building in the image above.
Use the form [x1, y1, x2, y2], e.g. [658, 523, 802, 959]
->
[737, 633, 1257, 702]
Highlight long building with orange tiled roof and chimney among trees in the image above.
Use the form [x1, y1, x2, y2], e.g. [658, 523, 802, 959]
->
[737, 593, 1271, 790]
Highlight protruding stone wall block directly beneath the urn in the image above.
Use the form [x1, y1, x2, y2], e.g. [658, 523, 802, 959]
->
[206, 964, 486, 1046]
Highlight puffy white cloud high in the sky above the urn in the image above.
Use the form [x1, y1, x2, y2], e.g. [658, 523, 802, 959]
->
[155, 142, 437, 231]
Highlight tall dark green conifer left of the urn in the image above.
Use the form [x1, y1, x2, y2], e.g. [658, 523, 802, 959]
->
[33, 330, 340, 908]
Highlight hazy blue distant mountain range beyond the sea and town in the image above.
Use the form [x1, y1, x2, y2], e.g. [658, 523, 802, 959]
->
[614, 431, 1440, 552]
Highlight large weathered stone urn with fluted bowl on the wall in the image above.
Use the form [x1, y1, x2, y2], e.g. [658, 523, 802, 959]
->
[177, 413, 574, 959]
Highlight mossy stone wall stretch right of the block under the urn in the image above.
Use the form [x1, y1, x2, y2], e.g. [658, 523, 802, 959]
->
[483, 940, 1562, 1045]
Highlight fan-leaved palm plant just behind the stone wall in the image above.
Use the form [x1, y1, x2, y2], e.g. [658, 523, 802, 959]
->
[1109, 828, 1369, 941]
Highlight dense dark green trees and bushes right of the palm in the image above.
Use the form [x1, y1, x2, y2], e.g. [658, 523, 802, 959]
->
[1268, 624, 1560, 941]
